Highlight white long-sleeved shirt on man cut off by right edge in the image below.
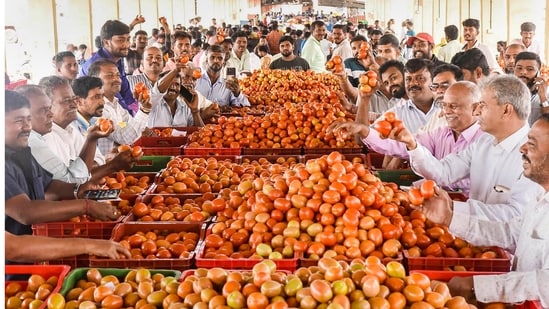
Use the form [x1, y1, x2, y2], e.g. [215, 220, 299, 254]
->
[450, 190, 549, 308]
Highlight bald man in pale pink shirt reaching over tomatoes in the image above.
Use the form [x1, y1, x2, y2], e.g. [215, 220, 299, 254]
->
[330, 81, 484, 195]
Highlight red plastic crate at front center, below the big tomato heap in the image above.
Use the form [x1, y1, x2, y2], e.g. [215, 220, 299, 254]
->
[196, 246, 299, 271]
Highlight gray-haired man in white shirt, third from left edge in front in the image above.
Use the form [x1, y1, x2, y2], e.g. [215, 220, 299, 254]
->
[36, 76, 110, 173]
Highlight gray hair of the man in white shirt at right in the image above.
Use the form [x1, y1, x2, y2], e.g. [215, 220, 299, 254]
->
[479, 74, 531, 120]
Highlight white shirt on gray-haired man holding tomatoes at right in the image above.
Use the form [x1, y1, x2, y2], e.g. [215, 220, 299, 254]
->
[408, 125, 539, 221]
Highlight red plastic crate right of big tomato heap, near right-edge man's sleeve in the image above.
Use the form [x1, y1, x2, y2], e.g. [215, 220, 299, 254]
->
[404, 248, 511, 272]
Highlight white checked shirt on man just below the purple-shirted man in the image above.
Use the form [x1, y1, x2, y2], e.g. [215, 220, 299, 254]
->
[98, 97, 149, 155]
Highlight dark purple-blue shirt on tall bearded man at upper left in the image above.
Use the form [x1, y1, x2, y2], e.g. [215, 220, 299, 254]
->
[78, 48, 139, 116]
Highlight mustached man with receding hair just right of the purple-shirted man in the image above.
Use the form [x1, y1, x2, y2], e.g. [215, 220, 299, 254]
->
[128, 46, 164, 91]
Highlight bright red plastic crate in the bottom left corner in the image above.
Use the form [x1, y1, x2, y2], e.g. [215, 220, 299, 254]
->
[4, 265, 71, 309]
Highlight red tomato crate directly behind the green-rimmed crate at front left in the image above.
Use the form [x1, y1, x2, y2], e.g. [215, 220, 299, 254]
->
[89, 222, 205, 270]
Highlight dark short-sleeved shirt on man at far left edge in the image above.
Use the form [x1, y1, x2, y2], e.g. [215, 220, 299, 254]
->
[5, 146, 52, 235]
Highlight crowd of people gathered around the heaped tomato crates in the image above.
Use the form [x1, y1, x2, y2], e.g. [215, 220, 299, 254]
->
[5, 11, 549, 307]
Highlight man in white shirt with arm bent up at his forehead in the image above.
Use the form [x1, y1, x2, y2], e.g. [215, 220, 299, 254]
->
[149, 68, 204, 128]
